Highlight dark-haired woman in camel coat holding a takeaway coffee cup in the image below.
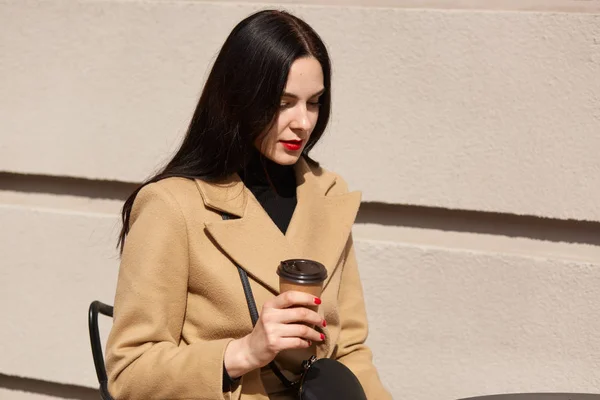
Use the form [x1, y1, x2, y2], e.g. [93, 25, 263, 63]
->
[106, 11, 391, 400]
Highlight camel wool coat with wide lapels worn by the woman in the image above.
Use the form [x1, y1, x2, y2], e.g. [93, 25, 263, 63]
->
[106, 158, 391, 400]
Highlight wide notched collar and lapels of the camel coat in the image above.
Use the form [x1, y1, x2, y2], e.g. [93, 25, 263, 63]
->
[196, 158, 361, 293]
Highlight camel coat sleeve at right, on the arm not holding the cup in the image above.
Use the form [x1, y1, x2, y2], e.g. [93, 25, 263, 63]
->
[336, 236, 392, 400]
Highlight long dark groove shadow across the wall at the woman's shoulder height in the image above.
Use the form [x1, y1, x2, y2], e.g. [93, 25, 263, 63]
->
[0, 172, 600, 246]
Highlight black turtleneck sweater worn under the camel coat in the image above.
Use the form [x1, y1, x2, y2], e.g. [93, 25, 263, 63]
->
[223, 151, 297, 392]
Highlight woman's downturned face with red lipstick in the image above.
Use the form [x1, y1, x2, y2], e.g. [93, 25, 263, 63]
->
[254, 57, 324, 165]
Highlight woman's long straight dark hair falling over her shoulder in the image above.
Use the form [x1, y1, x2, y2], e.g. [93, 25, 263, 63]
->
[118, 10, 331, 252]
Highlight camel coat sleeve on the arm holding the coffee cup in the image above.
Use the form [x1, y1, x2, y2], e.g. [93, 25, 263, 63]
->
[106, 183, 239, 400]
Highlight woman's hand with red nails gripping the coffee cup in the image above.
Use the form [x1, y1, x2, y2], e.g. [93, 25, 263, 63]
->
[224, 291, 326, 378]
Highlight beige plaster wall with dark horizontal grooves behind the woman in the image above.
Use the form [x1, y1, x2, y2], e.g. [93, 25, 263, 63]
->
[0, 0, 600, 400]
